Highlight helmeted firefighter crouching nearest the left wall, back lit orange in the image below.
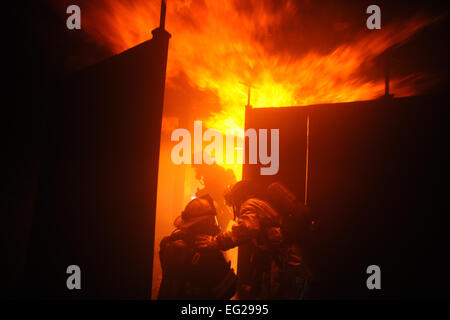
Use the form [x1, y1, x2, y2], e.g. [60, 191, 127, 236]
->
[158, 196, 236, 300]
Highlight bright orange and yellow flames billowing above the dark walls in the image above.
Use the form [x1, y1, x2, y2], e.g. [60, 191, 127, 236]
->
[76, 0, 432, 177]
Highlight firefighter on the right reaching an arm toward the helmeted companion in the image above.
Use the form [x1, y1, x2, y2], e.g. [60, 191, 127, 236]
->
[196, 181, 310, 299]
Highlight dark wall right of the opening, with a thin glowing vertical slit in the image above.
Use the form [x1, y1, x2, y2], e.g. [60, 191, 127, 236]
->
[244, 96, 449, 298]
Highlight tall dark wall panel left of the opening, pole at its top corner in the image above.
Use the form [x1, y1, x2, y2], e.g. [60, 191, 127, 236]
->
[23, 1, 170, 299]
